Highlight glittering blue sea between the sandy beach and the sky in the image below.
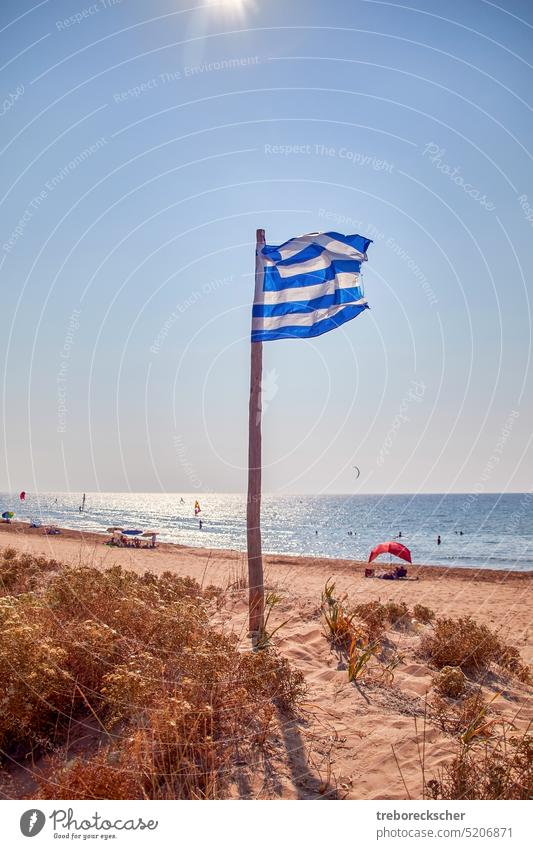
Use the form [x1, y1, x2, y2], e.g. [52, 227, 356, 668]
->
[0, 492, 533, 571]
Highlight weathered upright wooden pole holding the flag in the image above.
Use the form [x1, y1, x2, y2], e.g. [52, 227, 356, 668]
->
[246, 225, 265, 637]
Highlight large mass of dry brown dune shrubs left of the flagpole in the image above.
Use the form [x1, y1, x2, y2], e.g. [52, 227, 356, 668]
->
[0, 550, 304, 799]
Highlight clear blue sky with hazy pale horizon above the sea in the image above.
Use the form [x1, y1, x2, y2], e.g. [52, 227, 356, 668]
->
[0, 0, 533, 493]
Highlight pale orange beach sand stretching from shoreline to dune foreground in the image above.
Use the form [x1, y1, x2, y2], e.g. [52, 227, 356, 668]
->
[0, 523, 533, 799]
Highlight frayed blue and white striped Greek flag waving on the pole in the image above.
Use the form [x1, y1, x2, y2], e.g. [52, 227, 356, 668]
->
[252, 233, 372, 342]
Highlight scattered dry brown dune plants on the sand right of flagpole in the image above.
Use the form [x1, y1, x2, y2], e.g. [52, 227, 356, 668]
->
[321, 579, 533, 799]
